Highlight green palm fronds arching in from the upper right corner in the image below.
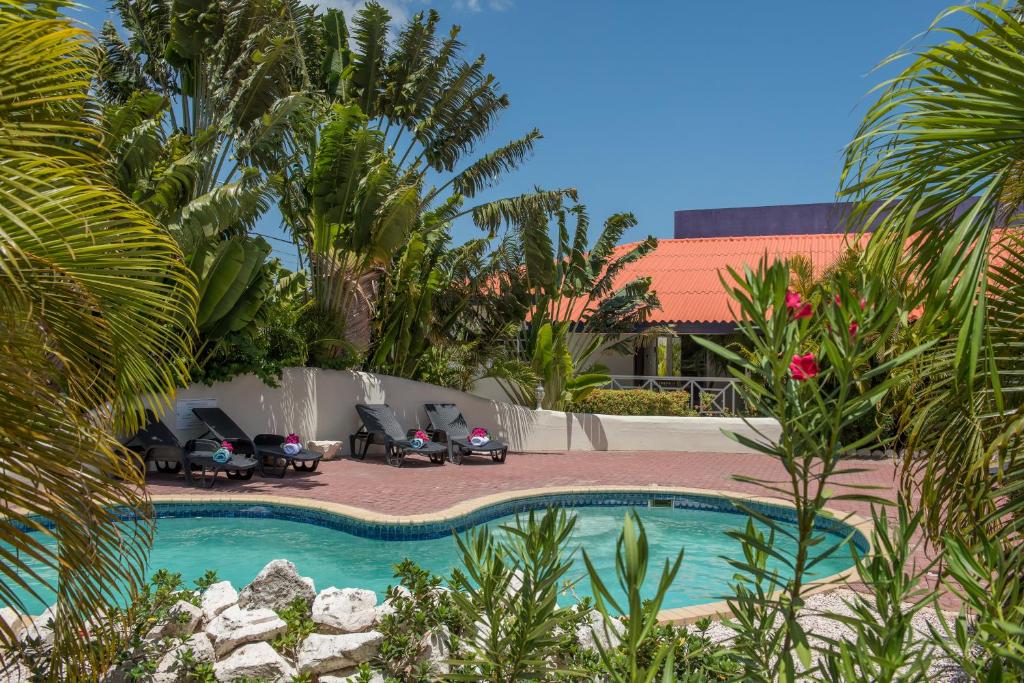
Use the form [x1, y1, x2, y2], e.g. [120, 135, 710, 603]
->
[843, 3, 1024, 385]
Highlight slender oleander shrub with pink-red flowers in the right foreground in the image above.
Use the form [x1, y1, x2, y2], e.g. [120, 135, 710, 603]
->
[699, 255, 922, 681]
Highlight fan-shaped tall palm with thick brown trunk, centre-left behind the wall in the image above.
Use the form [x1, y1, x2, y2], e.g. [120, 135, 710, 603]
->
[281, 2, 573, 358]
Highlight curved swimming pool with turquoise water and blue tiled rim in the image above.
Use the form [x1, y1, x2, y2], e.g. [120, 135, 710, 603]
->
[9, 492, 867, 611]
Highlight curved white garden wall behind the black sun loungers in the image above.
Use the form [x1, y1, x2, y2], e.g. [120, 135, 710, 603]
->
[164, 368, 779, 453]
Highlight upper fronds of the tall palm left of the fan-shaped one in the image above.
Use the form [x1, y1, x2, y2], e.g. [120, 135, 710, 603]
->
[97, 0, 314, 197]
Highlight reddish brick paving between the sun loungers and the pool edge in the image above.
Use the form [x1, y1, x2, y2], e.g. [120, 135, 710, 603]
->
[147, 452, 955, 608]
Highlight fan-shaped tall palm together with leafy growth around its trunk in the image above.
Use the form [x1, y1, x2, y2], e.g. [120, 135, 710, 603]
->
[281, 2, 571, 360]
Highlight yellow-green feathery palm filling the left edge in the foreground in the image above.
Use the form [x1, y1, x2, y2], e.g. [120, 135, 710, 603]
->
[0, 0, 196, 680]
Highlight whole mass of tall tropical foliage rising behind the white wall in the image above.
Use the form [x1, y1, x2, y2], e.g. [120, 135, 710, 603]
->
[96, 0, 638, 404]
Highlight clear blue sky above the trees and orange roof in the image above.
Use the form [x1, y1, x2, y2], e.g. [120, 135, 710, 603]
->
[79, 0, 950, 264]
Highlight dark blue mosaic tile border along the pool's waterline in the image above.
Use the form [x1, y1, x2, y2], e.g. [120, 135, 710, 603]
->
[12, 492, 870, 552]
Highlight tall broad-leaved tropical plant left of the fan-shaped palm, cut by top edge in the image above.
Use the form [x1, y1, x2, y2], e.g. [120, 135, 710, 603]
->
[96, 0, 312, 375]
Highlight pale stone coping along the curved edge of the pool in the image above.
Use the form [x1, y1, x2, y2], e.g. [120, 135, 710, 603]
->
[150, 484, 873, 625]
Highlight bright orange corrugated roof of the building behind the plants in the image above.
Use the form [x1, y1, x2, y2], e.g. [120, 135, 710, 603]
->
[615, 233, 856, 324]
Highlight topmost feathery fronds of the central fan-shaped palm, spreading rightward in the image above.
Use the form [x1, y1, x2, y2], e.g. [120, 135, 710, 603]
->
[307, 1, 574, 232]
